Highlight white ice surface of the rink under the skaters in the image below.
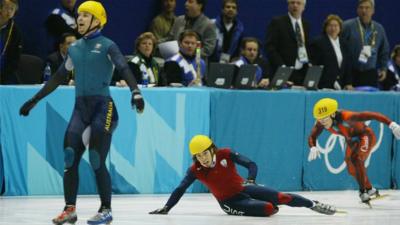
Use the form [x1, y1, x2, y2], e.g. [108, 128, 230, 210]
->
[0, 190, 400, 225]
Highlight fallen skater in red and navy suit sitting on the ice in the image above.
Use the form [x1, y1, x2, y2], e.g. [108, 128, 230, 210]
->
[150, 135, 336, 217]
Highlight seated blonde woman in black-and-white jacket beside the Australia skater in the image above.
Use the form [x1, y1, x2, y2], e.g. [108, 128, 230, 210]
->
[116, 32, 165, 87]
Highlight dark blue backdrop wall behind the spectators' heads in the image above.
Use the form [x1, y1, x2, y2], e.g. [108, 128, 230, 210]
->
[17, 0, 400, 57]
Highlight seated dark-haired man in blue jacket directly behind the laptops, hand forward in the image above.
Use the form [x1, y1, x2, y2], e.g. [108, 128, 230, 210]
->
[233, 37, 269, 88]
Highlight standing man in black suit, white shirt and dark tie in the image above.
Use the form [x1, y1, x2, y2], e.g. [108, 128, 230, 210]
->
[266, 0, 309, 86]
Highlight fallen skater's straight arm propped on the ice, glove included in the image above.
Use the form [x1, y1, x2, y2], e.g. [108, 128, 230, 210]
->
[149, 168, 196, 214]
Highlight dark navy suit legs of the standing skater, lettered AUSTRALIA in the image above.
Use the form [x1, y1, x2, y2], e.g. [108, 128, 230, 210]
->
[64, 96, 118, 208]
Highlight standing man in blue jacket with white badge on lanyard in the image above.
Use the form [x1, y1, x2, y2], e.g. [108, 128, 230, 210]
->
[343, 0, 390, 90]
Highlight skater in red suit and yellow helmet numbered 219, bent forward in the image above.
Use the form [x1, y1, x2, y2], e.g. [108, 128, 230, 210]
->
[308, 98, 400, 204]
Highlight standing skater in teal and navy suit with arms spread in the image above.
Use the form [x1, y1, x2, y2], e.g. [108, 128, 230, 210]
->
[20, 1, 144, 225]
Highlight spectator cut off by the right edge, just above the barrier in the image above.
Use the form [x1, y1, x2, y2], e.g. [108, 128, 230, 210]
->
[380, 45, 400, 91]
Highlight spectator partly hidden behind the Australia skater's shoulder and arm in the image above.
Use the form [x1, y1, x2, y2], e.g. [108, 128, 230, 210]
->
[46, 33, 76, 85]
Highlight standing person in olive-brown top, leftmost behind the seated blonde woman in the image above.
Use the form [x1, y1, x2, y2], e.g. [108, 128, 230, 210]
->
[150, 0, 176, 40]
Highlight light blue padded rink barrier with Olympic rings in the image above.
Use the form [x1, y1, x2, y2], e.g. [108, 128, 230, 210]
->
[0, 86, 400, 195]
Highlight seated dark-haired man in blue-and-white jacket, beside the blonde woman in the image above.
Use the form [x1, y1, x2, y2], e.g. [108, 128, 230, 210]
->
[164, 30, 206, 86]
